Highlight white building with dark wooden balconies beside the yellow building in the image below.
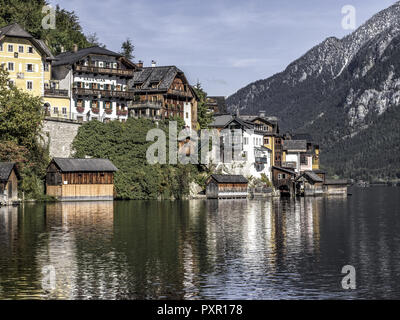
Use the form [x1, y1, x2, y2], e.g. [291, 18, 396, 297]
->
[52, 47, 137, 122]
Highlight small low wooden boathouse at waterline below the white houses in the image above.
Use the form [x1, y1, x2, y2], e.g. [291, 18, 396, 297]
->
[206, 174, 249, 199]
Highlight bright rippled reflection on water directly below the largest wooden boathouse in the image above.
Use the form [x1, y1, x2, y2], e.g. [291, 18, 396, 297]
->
[36, 202, 121, 299]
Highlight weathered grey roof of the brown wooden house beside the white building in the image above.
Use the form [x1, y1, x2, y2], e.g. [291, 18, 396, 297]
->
[131, 66, 188, 92]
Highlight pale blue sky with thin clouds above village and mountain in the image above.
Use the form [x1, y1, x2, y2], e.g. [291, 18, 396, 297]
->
[49, 0, 396, 96]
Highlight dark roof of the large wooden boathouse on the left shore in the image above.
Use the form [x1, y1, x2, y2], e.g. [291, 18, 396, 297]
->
[53, 158, 118, 172]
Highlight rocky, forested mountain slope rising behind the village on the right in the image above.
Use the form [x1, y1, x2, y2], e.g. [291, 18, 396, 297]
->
[227, 2, 400, 180]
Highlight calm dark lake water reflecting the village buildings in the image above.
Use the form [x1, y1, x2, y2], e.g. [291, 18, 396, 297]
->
[0, 187, 400, 299]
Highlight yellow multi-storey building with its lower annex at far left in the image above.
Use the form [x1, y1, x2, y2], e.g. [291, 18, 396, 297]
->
[0, 23, 70, 118]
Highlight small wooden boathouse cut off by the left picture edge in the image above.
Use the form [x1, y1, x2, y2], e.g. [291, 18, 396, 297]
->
[0, 162, 19, 205]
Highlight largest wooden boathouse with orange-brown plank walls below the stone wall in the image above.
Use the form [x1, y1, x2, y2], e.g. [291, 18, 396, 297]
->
[46, 158, 118, 201]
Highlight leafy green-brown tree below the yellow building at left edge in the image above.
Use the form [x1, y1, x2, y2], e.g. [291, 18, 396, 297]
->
[0, 68, 50, 199]
